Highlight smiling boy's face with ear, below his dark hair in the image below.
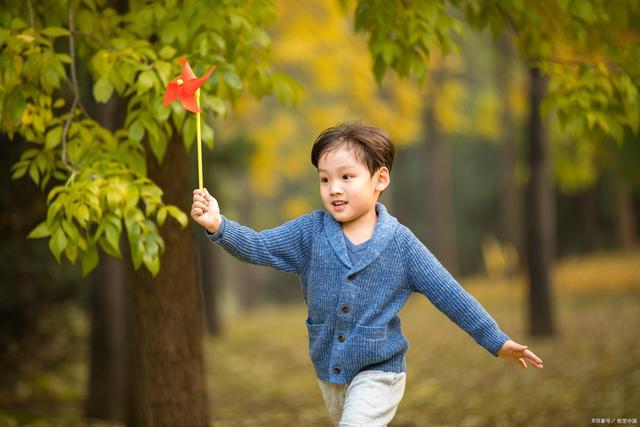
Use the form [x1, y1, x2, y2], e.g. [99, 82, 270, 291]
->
[318, 146, 390, 225]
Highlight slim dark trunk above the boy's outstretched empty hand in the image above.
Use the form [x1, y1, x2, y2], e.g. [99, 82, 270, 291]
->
[526, 68, 555, 336]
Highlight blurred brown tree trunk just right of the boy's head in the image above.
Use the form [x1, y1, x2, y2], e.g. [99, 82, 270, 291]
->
[424, 83, 457, 273]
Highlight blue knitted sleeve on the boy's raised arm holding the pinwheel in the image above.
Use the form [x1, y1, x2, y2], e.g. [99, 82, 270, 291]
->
[207, 214, 315, 273]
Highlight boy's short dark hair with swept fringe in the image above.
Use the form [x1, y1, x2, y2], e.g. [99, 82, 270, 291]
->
[311, 122, 396, 176]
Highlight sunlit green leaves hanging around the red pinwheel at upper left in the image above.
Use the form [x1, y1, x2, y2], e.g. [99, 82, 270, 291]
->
[0, 0, 295, 275]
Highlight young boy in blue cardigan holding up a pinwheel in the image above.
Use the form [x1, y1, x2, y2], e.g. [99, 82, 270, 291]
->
[191, 124, 542, 426]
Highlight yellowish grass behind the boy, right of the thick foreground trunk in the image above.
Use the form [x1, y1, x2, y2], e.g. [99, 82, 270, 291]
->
[206, 252, 640, 427]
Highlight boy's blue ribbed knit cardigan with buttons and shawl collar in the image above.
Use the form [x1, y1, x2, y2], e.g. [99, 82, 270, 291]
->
[207, 203, 509, 384]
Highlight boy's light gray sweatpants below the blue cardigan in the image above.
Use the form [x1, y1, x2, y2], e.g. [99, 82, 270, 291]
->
[318, 371, 407, 427]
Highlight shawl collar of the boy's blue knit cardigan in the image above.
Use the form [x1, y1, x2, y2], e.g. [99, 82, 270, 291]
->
[324, 203, 398, 274]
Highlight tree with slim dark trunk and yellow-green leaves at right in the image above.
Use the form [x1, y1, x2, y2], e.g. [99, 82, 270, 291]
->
[355, 0, 640, 335]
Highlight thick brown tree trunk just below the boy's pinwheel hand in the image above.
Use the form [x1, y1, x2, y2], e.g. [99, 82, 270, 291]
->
[128, 134, 209, 427]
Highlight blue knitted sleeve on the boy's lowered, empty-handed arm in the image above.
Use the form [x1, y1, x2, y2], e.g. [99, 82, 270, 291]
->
[404, 229, 509, 356]
